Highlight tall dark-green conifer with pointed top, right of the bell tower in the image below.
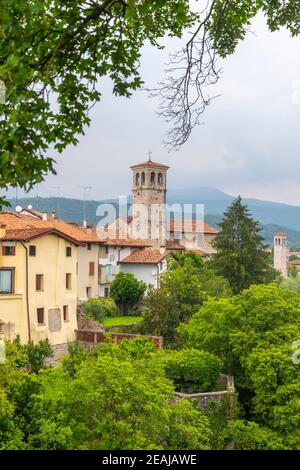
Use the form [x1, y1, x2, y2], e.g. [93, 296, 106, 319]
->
[211, 196, 275, 293]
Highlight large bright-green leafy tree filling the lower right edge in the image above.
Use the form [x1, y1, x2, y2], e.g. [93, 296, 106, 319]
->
[179, 285, 300, 449]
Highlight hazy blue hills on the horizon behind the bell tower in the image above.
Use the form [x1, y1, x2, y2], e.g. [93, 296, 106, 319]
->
[4, 187, 300, 248]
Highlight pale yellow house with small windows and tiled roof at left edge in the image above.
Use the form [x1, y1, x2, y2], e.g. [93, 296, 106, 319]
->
[0, 215, 80, 345]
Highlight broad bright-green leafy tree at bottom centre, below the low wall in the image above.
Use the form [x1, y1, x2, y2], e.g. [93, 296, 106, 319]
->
[17, 340, 210, 450]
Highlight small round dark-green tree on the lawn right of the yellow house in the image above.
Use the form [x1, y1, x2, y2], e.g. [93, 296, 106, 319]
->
[110, 273, 147, 315]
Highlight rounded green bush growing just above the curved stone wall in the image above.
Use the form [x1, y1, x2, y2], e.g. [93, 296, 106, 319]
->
[161, 349, 222, 392]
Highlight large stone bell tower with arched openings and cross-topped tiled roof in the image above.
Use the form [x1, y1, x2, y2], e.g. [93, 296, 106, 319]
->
[131, 152, 169, 247]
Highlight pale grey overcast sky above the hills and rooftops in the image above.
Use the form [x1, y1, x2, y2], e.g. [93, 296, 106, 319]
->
[5, 11, 300, 205]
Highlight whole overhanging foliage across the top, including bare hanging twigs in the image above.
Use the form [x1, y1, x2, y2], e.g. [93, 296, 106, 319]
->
[0, 0, 300, 198]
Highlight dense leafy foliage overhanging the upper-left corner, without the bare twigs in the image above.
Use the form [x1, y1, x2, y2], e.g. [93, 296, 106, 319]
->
[0, 0, 193, 200]
